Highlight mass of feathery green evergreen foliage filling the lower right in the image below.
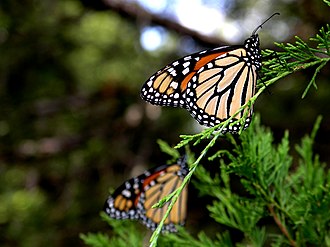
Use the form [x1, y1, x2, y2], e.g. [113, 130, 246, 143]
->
[157, 117, 330, 246]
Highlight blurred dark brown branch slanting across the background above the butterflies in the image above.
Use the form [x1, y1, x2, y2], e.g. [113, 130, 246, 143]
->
[104, 0, 228, 47]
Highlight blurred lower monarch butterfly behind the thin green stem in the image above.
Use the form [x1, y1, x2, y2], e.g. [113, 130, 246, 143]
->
[104, 156, 189, 232]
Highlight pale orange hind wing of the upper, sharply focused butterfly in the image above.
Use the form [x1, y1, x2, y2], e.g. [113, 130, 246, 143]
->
[186, 47, 257, 132]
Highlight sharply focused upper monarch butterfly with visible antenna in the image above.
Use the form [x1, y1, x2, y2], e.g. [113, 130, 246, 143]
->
[141, 13, 279, 133]
